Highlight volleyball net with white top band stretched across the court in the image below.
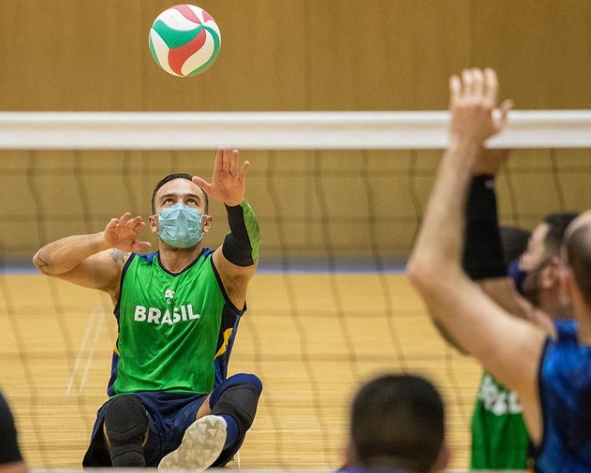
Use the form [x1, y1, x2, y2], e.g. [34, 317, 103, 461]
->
[0, 111, 591, 469]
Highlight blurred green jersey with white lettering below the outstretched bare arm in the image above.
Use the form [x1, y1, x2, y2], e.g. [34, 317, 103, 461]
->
[470, 373, 529, 470]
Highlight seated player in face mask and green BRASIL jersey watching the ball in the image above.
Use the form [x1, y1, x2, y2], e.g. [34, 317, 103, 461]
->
[33, 149, 262, 471]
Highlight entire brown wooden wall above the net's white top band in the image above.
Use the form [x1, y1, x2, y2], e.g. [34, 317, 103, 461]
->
[0, 0, 591, 111]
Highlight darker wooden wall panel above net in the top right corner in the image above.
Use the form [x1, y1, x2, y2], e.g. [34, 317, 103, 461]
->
[470, 0, 591, 109]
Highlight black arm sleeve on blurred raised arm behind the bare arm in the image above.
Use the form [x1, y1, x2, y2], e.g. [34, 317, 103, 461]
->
[462, 175, 507, 280]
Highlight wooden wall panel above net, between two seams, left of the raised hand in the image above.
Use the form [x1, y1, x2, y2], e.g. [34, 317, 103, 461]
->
[308, 0, 469, 110]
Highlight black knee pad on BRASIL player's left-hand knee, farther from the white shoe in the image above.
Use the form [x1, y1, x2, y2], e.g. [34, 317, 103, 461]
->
[105, 395, 148, 467]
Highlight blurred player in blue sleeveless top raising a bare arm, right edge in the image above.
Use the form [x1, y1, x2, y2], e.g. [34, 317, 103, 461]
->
[408, 69, 591, 473]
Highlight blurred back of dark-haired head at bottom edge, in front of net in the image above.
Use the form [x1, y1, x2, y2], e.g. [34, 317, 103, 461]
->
[351, 375, 445, 473]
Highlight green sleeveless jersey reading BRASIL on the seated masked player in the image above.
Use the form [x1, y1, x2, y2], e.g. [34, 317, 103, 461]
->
[109, 250, 243, 395]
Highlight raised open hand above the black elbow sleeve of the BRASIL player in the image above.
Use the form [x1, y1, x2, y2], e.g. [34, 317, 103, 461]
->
[193, 148, 250, 207]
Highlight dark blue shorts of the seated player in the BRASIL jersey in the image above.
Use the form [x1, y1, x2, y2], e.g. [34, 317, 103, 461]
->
[82, 392, 207, 467]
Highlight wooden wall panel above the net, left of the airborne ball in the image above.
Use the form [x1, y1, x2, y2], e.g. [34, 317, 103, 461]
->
[0, 0, 146, 110]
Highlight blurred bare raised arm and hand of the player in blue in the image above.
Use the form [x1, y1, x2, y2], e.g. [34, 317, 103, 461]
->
[408, 70, 545, 441]
